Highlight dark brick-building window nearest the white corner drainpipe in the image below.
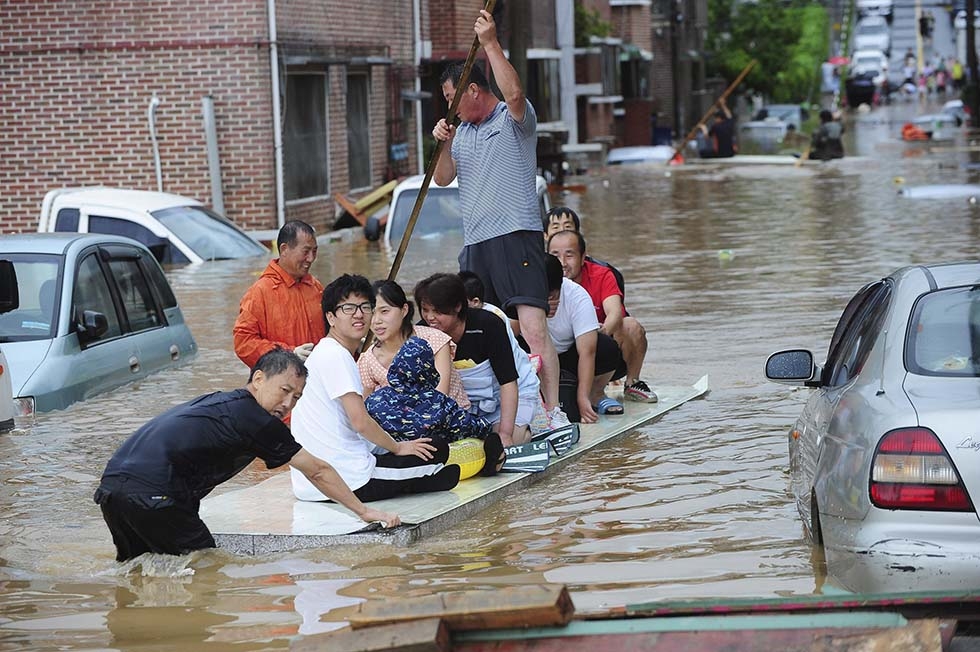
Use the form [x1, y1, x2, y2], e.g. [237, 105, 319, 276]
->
[283, 73, 330, 200]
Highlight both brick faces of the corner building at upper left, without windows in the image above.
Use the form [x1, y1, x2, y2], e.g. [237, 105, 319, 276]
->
[0, 0, 426, 232]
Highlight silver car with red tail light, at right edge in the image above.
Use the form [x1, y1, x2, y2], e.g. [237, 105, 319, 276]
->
[766, 263, 980, 592]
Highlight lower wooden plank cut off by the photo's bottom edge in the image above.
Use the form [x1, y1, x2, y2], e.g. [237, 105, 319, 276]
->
[289, 618, 453, 652]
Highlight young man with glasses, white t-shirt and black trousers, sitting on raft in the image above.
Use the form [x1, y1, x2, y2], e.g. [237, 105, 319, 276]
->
[292, 274, 459, 502]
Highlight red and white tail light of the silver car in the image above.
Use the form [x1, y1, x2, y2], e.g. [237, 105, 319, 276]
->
[871, 428, 973, 512]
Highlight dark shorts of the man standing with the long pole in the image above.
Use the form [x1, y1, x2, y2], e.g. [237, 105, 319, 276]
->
[459, 231, 548, 319]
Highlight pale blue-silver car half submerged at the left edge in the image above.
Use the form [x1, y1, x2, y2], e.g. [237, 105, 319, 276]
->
[0, 233, 197, 416]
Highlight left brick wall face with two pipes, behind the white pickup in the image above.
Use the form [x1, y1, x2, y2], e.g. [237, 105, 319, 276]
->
[0, 0, 274, 232]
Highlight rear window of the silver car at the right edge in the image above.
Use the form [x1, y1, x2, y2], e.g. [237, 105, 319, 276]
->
[906, 286, 980, 377]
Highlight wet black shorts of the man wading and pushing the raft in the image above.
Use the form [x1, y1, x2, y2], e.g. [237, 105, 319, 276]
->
[95, 487, 216, 561]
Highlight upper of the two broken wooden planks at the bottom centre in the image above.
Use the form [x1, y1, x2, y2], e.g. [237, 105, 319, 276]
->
[348, 584, 575, 631]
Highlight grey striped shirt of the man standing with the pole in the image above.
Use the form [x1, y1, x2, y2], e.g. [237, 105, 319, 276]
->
[451, 100, 541, 245]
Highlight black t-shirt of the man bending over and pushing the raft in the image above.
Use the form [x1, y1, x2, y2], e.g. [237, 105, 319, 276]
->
[102, 389, 302, 501]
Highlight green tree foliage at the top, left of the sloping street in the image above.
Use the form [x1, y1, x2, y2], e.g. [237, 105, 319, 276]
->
[707, 0, 829, 102]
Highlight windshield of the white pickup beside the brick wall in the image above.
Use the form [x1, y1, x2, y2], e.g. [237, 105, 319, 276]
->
[153, 206, 269, 260]
